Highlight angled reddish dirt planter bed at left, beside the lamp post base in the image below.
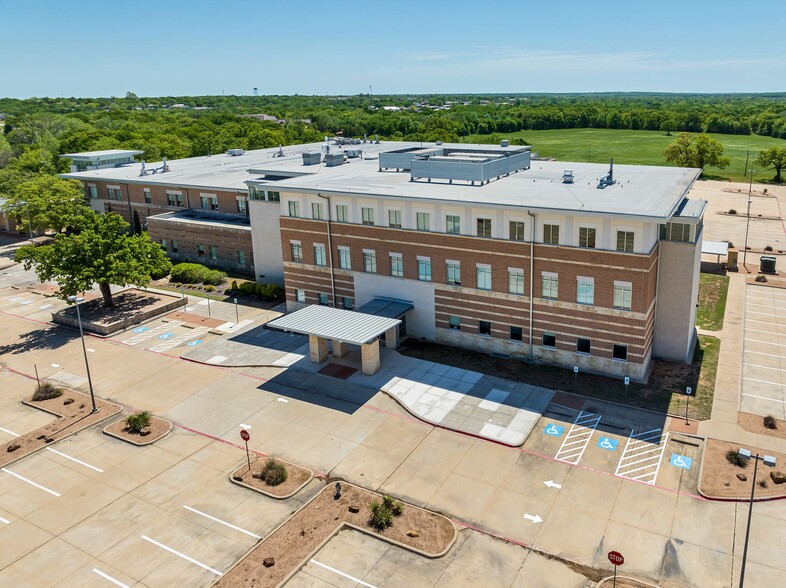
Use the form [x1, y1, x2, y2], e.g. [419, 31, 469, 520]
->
[0, 388, 123, 466]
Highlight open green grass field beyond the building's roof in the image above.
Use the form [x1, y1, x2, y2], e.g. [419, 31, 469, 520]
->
[464, 129, 786, 182]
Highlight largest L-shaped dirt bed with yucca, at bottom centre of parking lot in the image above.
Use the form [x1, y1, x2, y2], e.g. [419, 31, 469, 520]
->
[213, 482, 456, 588]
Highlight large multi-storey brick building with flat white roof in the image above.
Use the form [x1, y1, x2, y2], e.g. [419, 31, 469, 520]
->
[59, 143, 705, 379]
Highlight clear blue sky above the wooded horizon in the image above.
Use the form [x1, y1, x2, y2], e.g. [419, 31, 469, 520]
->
[0, 0, 786, 98]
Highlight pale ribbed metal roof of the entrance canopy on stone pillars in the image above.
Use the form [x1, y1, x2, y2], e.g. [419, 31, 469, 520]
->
[267, 304, 401, 345]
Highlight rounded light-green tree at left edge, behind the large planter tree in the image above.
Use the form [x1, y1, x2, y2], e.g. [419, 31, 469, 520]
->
[3, 175, 90, 233]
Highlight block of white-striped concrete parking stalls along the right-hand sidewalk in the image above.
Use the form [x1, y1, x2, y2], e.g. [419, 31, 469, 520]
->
[740, 285, 786, 419]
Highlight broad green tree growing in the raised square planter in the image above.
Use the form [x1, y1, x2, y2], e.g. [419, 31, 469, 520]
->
[15, 210, 168, 307]
